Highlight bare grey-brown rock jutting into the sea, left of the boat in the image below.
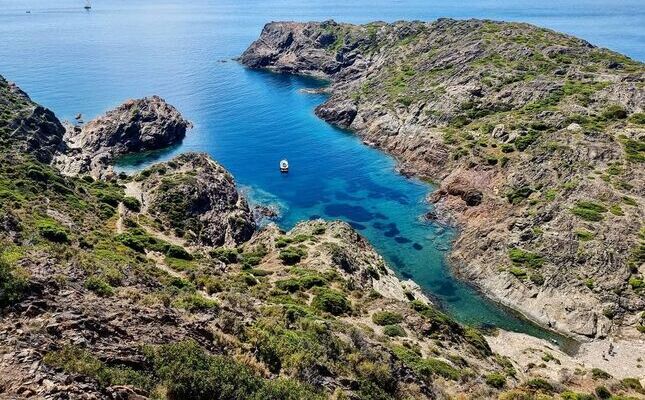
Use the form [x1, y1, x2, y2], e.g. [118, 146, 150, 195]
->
[54, 96, 191, 176]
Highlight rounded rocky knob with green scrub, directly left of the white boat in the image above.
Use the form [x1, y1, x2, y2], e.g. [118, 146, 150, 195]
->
[134, 153, 256, 246]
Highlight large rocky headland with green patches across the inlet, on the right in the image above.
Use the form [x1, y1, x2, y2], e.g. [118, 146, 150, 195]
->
[240, 19, 645, 340]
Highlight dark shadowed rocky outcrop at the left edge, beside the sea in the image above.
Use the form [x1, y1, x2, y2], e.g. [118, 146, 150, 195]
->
[0, 76, 65, 163]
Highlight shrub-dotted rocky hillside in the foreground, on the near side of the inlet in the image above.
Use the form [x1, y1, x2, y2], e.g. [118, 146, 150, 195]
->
[0, 74, 642, 399]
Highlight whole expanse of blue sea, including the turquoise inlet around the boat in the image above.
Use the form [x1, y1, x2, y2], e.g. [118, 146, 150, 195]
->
[0, 0, 645, 348]
